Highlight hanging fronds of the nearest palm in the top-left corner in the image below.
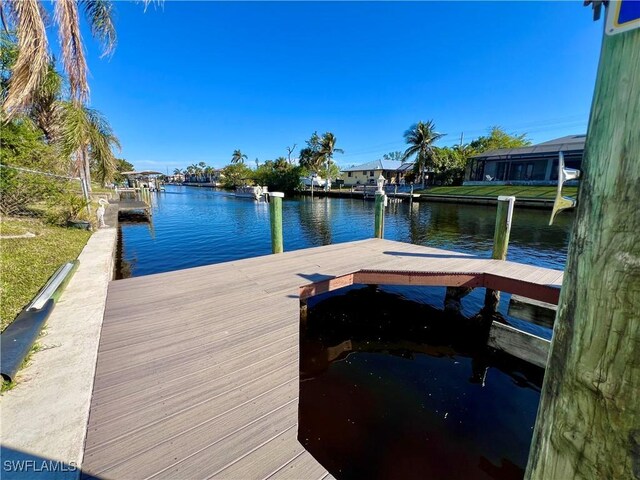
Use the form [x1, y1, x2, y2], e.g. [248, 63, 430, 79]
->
[0, 0, 126, 119]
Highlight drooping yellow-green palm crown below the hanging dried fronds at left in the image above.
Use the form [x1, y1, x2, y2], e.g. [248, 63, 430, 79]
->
[58, 101, 120, 191]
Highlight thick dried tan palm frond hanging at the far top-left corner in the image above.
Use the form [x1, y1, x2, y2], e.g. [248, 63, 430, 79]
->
[3, 0, 49, 120]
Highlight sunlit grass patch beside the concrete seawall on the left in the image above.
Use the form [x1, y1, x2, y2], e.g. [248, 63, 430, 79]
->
[0, 217, 91, 331]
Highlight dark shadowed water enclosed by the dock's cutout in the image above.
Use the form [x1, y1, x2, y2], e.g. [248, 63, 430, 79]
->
[298, 286, 544, 480]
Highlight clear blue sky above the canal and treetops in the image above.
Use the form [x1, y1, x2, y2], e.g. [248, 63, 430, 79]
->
[74, 1, 602, 172]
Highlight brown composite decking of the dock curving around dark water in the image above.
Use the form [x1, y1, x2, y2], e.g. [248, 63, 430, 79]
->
[82, 239, 562, 480]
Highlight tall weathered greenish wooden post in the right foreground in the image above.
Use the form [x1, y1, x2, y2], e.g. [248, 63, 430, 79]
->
[526, 13, 640, 480]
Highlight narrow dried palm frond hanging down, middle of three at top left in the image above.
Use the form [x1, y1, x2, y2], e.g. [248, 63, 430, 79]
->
[55, 0, 89, 100]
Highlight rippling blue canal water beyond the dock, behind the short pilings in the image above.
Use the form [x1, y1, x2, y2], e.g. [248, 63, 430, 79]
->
[122, 186, 573, 276]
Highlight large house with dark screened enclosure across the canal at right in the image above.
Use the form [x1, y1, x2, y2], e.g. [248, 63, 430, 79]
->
[464, 135, 586, 185]
